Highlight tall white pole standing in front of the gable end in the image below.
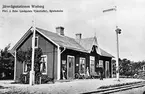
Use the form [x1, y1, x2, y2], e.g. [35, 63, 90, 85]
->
[29, 20, 36, 85]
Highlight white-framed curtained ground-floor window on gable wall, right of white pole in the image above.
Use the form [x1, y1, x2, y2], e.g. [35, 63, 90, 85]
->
[40, 55, 47, 74]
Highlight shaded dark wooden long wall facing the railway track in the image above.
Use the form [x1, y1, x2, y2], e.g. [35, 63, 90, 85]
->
[61, 49, 112, 79]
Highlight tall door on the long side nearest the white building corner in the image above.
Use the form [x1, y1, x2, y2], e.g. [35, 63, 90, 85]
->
[67, 55, 75, 79]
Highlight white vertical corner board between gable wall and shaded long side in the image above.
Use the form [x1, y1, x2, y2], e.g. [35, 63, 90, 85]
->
[57, 46, 61, 80]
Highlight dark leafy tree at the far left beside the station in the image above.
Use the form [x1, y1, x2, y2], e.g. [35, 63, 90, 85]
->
[0, 44, 14, 79]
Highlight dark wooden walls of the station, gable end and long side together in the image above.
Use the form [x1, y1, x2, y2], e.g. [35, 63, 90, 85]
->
[15, 28, 112, 81]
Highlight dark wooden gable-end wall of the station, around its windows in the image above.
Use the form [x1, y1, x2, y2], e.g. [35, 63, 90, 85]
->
[15, 32, 57, 81]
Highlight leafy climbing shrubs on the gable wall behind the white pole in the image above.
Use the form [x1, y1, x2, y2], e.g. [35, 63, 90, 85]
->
[17, 48, 50, 84]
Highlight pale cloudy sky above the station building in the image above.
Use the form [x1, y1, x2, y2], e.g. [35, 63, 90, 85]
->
[0, 0, 145, 61]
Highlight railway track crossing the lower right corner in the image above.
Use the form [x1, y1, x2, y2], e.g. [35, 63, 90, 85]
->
[82, 81, 145, 94]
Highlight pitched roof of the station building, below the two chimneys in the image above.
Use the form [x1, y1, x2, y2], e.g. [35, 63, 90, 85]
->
[12, 28, 113, 57]
